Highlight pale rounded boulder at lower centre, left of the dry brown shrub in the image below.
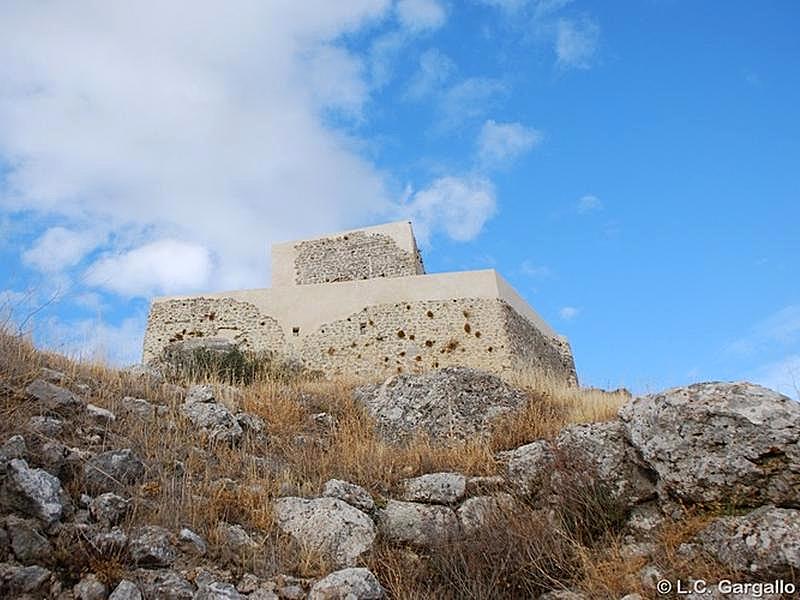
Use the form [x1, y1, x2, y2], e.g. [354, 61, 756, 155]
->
[274, 497, 375, 566]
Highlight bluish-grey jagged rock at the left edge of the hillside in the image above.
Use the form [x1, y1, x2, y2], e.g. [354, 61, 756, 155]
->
[0, 458, 64, 525]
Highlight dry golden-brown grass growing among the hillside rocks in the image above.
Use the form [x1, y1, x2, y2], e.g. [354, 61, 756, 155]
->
[0, 334, 644, 599]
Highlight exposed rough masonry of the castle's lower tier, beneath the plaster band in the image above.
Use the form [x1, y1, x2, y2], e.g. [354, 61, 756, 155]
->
[145, 298, 575, 382]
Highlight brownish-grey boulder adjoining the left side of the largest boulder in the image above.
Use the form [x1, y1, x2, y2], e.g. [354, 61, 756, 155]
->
[555, 420, 656, 506]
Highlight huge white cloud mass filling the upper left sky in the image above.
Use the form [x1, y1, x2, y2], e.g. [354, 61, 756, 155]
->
[0, 0, 393, 290]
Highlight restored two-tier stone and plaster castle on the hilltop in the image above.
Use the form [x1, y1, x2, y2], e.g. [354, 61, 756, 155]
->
[143, 221, 577, 384]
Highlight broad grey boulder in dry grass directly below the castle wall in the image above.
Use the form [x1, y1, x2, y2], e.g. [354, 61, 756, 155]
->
[355, 367, 528, 441]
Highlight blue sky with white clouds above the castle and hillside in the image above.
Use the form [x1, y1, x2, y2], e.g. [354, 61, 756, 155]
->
[0, 0, 800, 396]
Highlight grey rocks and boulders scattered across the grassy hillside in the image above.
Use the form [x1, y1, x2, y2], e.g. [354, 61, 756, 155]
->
[0, 369, 800, 600]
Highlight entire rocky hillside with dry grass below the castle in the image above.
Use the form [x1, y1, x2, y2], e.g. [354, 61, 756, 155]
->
[0, 335, 800, 600]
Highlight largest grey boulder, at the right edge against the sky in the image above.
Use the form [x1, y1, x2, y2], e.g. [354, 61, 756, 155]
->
[619, 382, 800, 507]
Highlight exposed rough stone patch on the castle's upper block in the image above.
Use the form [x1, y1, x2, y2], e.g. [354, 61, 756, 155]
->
[294, 231, 425, 285]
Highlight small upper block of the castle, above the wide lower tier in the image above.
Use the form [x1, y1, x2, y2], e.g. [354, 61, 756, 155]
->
[272, 222, 425, 288]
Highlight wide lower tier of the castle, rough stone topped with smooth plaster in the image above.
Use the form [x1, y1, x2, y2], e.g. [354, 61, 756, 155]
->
[144, 271, 575, 382]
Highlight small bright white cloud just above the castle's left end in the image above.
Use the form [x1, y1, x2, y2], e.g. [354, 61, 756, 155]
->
[86, 239, 213, 297]
